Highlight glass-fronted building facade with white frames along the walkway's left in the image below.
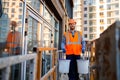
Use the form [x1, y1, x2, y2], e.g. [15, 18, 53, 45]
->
[0, 0, 73, 80]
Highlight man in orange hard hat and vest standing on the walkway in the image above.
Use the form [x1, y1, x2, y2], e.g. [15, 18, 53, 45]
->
[61, 19, 85, 80]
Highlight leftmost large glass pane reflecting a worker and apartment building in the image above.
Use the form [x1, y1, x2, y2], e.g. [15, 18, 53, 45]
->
[0, 0, 23, 57]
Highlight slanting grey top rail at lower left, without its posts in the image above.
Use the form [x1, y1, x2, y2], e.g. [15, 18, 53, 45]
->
[0, 54, 36, 69]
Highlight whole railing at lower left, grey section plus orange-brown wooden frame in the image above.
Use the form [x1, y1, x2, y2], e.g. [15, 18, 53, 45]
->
[0, 47, 61, 80]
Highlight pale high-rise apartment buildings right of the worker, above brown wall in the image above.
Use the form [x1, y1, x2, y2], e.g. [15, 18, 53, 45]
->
[73, 0, 120, 41]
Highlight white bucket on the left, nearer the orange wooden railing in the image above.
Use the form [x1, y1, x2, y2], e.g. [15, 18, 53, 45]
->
[59, 60, 70, 73]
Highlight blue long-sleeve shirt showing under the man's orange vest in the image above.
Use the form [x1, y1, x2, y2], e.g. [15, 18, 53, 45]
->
[61, 31, 86, 53]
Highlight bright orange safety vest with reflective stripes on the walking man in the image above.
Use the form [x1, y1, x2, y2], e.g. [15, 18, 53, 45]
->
[64, 31, 82, 55]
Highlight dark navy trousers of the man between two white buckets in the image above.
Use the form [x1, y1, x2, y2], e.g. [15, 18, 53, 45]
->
[66, 55, 80, 80]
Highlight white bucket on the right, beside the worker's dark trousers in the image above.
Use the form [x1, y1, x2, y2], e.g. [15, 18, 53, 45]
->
[77, 60, 89, 74]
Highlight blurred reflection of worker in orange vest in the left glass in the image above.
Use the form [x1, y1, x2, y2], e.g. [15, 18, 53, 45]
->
[6, 21, 21, 55]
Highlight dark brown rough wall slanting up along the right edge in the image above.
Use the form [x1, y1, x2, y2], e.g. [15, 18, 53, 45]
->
[95, 22, 120, 80]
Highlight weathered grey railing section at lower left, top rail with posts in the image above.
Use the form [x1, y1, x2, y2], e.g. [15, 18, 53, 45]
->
[0, 54, 37, 80]
